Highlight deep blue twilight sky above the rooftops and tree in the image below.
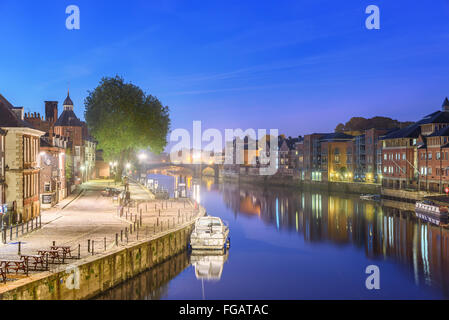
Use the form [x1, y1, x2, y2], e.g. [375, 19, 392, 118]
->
[0, 0, 449, 144]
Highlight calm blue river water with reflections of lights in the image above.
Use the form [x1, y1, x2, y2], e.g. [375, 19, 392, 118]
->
[99, 177, 449, 299]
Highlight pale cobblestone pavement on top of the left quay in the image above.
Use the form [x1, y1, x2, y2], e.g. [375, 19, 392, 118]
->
[0, 181, 198, 286]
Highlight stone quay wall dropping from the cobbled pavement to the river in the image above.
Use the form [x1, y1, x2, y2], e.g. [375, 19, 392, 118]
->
[0, 212, 200, 300]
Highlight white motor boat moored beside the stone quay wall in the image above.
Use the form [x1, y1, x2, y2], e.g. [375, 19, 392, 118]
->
[190, 216, 230, 250]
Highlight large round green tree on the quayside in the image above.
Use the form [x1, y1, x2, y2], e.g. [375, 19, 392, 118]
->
[84, 76, 170, 178]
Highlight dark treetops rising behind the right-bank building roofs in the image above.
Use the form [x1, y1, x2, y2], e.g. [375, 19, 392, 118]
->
[335, 117, 412, 132]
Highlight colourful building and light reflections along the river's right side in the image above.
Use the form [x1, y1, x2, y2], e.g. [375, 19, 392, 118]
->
[220, 184, 449, 296]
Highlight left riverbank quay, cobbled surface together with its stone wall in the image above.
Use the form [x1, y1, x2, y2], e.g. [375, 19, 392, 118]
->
[0, 180, 205, 300]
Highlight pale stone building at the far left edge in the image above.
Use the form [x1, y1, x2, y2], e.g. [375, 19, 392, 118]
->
[0, 95, 44, 223]
